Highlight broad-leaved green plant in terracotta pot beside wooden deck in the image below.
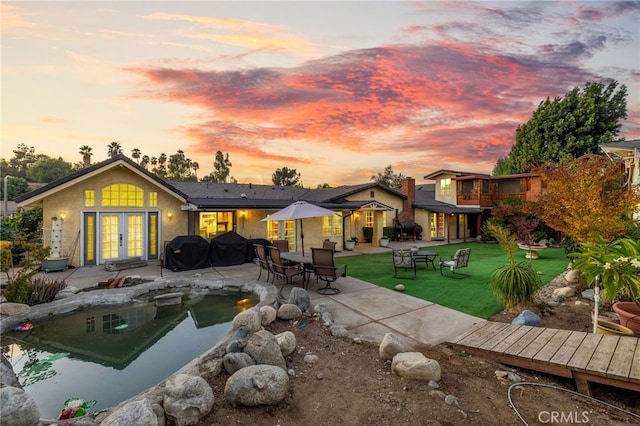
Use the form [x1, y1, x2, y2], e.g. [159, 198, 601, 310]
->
[569, 236, 640, 335]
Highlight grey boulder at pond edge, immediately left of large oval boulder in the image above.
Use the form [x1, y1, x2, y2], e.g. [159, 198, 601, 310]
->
[163, 374, 213, 426]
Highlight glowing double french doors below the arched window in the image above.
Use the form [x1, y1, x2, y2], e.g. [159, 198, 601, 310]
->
[99, 213, 145, 263]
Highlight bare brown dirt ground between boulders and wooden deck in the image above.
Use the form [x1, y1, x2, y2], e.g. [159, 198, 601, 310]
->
[195, 280, 640, 426]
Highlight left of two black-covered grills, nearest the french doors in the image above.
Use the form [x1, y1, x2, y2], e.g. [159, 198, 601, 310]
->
[165, 235, 211, 271]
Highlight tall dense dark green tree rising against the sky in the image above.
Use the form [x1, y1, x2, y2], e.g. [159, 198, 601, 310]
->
[494, 81, 627, 174]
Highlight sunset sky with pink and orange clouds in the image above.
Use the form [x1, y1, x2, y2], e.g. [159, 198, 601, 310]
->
[1, 1, 640, 187]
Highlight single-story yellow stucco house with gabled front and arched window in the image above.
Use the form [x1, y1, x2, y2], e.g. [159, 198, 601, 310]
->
[16, 155, 407, 266]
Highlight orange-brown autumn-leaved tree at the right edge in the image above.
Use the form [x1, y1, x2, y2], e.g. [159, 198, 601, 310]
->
[535, 155, 640, 245]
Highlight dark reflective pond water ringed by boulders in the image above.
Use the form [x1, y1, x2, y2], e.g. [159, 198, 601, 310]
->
[2, 290, 259, 419]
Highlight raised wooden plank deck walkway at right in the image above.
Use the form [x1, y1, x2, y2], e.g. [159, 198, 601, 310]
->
[450, 322, 640, 395]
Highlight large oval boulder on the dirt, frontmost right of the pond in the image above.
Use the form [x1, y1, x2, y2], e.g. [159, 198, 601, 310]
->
[224, 365, 289, 407]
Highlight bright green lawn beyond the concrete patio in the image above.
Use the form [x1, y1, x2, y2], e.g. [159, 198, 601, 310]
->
[336, 242, 569, 318]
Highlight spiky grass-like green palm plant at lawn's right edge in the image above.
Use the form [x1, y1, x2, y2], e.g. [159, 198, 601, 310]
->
[485, 220, 540, 310]
